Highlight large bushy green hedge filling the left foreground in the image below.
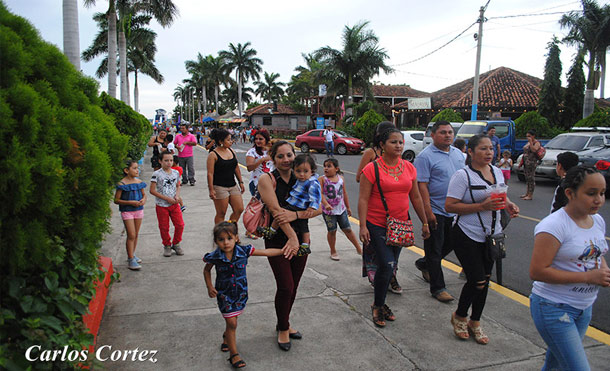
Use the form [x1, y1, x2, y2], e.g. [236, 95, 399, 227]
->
[0, 2, 128, 369]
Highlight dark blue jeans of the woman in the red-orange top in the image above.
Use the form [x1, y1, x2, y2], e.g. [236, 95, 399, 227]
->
[366, 221, 402, 307]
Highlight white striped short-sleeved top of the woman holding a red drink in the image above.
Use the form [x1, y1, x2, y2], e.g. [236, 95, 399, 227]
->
[447, 166, 504, 242]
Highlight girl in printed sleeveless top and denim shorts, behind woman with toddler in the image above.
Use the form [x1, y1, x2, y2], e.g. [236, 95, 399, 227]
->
[318, 158, 362, 260]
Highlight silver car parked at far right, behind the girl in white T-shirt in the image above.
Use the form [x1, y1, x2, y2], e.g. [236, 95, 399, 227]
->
[513, 132, 610, 181]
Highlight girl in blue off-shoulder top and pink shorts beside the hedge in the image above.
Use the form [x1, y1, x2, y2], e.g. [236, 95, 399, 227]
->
[114, 160, 146, 271]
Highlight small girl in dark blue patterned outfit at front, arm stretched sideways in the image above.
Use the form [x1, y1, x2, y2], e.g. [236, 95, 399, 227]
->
[203, 222, 282, 368]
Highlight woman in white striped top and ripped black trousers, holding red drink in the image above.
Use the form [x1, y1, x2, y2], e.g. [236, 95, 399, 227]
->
[445, 135, 519, 344]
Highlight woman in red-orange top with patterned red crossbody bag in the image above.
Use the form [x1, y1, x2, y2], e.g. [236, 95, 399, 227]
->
[358, 128, 430, 327]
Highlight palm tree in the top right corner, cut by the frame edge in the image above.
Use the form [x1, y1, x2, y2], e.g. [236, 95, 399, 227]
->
[559, 0, 610, 118]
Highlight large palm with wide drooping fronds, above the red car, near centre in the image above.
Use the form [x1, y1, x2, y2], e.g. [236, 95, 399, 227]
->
[314, 21, 393, 115]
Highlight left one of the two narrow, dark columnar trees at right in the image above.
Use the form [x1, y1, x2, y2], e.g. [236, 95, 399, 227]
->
[538, 36, 563, 126]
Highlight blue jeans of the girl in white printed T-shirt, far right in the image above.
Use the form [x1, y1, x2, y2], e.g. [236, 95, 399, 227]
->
[530, 294, 593, 371]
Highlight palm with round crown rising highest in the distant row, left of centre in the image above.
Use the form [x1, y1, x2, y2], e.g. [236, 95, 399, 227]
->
[219, 41, 263, 117]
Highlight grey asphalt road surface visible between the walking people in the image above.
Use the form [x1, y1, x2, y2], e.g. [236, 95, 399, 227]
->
[233, 144, 610, 333]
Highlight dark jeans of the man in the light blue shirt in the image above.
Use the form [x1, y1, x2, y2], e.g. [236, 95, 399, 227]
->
[415, 214, 453, 295]
